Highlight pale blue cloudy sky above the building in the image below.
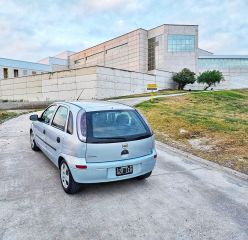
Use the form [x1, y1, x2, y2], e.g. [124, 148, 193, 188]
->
[0, 0, 248, 61]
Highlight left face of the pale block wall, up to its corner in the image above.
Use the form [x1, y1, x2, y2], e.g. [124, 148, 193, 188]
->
[0, 67, 96, 101]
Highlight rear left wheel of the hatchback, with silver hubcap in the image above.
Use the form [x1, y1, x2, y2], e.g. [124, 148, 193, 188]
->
[59, 160, 80, 194]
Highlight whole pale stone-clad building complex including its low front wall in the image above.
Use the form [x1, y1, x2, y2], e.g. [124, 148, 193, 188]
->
[0, 24, 248, 101]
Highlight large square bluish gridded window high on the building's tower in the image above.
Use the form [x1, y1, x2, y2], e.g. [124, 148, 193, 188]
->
[168, 34, 195, 52]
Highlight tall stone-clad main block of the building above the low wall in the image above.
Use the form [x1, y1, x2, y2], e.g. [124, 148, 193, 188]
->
[69, 24, 198, 73]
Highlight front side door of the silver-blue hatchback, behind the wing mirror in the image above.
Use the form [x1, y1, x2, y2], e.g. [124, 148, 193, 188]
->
[33, 105, 57, 153]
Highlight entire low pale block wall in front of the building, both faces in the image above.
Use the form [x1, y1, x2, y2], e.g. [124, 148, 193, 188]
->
[0, 66, 173, 101]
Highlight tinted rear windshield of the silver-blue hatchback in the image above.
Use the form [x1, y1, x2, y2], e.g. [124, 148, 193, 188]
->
[87, 110, 152, 143]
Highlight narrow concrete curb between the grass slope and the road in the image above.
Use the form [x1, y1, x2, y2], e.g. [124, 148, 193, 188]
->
[156, 141, 248, 181]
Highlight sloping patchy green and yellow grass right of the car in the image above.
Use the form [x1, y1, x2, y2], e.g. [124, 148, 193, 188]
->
[137, 90, 248, 173]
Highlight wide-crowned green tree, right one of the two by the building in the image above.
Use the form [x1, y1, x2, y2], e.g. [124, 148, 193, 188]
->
[197, 70, 224, 90]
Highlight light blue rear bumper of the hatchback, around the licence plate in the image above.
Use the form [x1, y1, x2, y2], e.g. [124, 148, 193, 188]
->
[65, 150, 156, 183]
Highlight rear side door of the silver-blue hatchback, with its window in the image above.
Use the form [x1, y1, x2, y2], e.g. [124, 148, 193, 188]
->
[46, 105, 69, 165]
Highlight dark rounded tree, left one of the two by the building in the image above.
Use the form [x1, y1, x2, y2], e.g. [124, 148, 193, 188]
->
[172, 68, 196, 90]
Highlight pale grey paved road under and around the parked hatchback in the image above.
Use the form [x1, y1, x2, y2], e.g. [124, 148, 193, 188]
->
[0, 98, 248, 240]
